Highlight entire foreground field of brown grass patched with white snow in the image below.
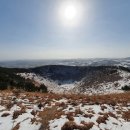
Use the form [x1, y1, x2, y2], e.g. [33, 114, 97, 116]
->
[0, 92, 130, 130]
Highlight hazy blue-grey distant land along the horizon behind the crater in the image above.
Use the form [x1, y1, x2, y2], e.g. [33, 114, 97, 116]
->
[0, 57, 130, 68]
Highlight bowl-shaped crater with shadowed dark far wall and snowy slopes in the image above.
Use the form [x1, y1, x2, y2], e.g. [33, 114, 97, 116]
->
[18, 66, 130, 94]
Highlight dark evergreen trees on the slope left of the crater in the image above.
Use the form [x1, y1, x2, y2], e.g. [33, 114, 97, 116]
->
[0, 68, 47, 92]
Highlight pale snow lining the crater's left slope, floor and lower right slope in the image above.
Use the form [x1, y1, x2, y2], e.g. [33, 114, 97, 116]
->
[18, 70, 130, 94]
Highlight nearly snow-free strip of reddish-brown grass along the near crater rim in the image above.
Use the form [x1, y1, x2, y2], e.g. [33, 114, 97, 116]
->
[29, 92, 130, 109]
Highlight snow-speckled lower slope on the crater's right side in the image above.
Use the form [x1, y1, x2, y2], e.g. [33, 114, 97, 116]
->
[72, 70, 130, 94]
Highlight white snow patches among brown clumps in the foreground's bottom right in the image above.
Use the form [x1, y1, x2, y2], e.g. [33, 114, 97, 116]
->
[49, 104, 130, 130]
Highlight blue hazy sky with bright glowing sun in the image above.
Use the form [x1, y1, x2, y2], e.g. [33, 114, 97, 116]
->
[0, 0, 130, 61]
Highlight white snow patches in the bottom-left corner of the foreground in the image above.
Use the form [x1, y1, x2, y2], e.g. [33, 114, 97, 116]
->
[0, 94, 40, 130]
